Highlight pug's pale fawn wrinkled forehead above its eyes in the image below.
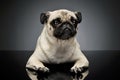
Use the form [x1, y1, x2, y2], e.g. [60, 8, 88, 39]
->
[49, 10, 76, 21]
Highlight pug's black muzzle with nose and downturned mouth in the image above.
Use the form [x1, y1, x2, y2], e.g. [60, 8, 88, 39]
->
[54, 24, 76, 40]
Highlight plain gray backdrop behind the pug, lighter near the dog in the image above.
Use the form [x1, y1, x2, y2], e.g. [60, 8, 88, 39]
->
[0, 0, 120, 50]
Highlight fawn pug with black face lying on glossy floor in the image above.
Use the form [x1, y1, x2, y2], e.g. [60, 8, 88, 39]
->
[26, 9, 89, 80]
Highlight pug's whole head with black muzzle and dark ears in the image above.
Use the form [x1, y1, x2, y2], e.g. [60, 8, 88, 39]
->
[40, 9, 82, 40]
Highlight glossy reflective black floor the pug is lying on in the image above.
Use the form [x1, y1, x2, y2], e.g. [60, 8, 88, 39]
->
[0, 51, 120, 80]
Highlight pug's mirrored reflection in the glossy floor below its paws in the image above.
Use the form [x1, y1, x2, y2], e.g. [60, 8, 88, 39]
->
[27, 63, 89, 80]
